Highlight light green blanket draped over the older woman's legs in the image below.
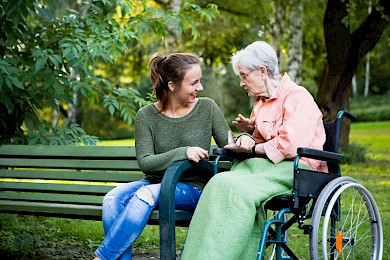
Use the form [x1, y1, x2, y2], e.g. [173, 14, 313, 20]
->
[181, 158, 294, 260]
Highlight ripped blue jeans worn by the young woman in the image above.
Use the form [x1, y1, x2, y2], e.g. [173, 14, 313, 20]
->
[95, 180, 201, 260]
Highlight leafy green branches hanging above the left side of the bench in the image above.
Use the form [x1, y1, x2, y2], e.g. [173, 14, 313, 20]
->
[0, 0, 217, 143]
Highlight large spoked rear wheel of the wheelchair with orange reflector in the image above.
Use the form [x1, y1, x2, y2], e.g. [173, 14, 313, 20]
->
[310, 177, 383, 260]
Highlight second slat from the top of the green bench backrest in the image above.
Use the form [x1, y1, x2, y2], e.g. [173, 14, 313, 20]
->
[0, 158, 139, 171]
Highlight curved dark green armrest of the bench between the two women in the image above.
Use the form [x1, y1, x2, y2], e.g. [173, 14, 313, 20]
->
[159, 160, 213, 259]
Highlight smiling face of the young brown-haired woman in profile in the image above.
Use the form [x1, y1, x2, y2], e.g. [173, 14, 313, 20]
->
[173, 64, 203, 104]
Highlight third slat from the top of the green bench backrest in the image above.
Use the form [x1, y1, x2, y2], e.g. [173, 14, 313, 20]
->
[0, 169, 144, 182]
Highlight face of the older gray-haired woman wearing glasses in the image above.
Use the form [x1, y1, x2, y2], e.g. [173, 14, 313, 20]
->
[237, 64, 268, 97]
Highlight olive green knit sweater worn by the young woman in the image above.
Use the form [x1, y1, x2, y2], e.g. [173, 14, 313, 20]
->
[135, 98, 229, 189]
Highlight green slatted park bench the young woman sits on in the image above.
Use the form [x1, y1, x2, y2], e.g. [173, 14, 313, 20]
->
[0, 145, 225, 259]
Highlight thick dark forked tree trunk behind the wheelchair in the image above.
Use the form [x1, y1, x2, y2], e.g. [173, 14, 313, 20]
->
[317, 0, 390, 147]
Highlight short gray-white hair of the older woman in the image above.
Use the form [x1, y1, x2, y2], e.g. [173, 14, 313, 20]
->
[231, 41, 280, 79]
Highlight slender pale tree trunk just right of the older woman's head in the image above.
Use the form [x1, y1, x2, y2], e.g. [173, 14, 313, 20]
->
[288, 0, 303, 84]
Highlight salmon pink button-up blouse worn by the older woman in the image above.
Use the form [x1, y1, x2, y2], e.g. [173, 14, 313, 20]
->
[251, 73, 327, 171]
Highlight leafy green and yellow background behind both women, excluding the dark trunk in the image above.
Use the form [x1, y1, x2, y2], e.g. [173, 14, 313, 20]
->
[0, 0, 390, 144]
